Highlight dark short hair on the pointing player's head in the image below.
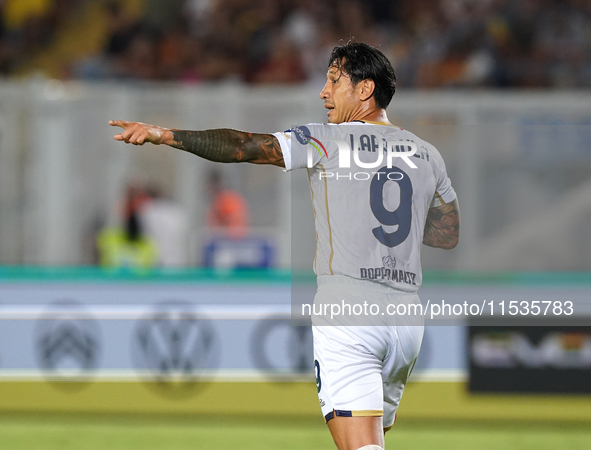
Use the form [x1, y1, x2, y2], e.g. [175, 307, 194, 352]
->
[328, 41, 396, 109]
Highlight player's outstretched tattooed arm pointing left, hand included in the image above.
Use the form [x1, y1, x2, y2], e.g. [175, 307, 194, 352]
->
[109, 120, 285, 167]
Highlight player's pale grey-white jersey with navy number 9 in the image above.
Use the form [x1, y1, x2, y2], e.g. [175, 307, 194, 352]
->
[274, 122, 456, 292]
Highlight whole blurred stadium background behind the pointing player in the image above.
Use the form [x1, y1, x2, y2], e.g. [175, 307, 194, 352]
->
[0, 0, 591, 449]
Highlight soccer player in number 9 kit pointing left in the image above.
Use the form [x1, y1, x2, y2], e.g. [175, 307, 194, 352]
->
[109, 42, 459, 450]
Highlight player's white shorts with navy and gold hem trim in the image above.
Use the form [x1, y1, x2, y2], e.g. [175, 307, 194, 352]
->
[312, 276, 424, 428]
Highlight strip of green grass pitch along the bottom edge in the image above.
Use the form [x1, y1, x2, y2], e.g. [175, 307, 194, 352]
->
[0, 414, 591, 450]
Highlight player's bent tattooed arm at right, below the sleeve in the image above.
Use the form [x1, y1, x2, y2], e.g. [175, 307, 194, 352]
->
[423, 199, 460, 250]
